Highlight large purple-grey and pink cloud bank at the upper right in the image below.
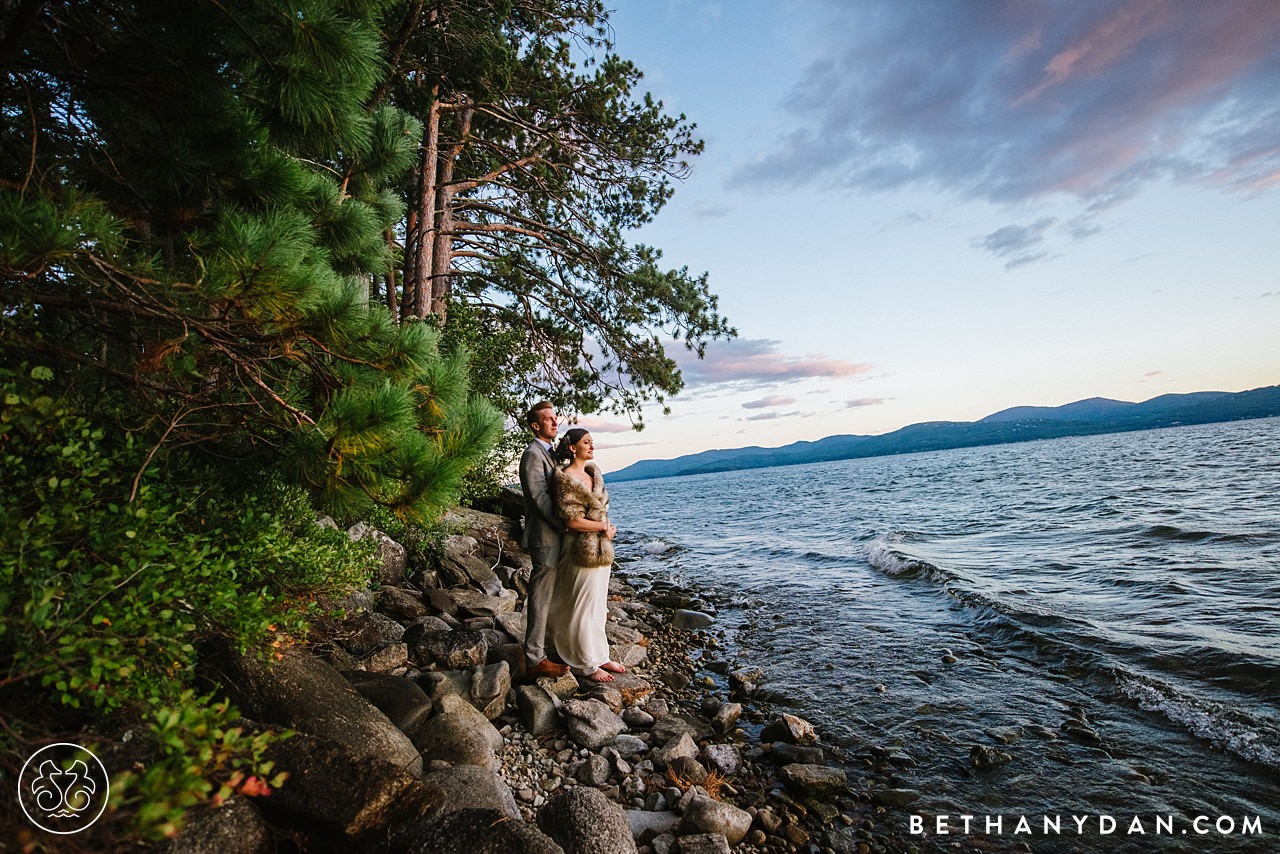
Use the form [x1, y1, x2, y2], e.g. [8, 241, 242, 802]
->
[732, 0, 1280, 204]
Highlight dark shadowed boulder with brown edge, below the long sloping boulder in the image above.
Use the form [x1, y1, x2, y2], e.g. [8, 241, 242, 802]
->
[247, 732, 444, 848]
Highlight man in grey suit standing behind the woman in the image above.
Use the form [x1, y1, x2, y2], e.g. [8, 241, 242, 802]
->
[520, 401, 568, 679]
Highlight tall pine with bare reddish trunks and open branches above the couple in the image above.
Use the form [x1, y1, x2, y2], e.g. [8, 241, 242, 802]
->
[373, 0, 733, 424]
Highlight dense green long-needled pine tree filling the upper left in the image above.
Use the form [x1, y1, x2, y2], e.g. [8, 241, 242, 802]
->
[0, 0, 500, 515]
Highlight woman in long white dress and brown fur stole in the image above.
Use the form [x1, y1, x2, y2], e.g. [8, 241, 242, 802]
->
[547, 428, 626, 682]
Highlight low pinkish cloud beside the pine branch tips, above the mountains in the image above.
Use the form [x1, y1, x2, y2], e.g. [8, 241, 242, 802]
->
[668, 338, 872, 388]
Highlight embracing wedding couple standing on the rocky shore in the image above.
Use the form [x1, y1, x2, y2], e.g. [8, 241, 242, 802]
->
[520, 401, 626, 682]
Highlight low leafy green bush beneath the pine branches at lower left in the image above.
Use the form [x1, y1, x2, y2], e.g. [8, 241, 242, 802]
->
[0, 366, 372, 836]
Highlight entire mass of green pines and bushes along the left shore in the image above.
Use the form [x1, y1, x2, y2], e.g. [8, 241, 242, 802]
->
[0, 0, 732, 850]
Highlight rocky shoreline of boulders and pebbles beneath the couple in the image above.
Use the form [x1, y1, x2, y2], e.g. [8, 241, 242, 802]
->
[169, 510, 922, 854]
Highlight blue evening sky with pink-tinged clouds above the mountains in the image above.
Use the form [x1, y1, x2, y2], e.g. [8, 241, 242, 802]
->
[582, 0, 1280, 471]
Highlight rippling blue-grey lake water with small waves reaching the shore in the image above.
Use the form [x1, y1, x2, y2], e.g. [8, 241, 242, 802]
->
[600, 419, 1280, 851]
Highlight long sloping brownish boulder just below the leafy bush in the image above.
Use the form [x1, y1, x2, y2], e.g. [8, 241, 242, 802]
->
[220, 652, 422, 773]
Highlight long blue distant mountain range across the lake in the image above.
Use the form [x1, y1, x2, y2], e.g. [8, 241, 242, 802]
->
[609, 385, 1280, 483]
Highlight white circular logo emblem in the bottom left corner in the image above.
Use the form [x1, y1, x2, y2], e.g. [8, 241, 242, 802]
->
[18, 741, 111, 834]
